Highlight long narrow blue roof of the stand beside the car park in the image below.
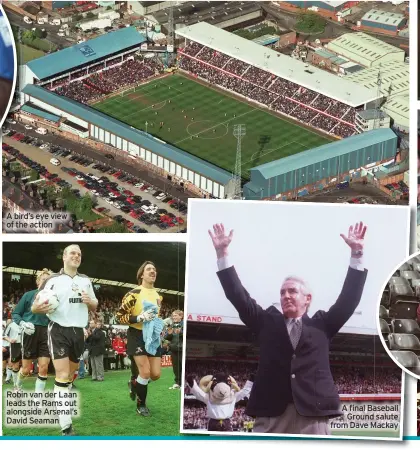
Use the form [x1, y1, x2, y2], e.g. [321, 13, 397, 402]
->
[22, 84, 232, 186]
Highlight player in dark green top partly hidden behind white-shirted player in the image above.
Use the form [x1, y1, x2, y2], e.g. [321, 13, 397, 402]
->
[12, 269, 52, 392]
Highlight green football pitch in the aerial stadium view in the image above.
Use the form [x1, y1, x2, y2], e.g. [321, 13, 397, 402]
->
[93, 74, 333, 178]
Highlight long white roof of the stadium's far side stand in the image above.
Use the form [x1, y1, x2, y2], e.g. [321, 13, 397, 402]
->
[176, 22, 377, 107]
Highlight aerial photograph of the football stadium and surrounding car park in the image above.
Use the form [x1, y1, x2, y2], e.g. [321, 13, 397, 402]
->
[2, 1, 410, 233]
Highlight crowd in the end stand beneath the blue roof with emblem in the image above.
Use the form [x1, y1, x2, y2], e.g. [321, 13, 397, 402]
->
[49, 57, 164, 103]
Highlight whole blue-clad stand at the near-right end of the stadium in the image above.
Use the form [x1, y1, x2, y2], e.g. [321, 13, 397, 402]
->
[244, 128, 397, 200]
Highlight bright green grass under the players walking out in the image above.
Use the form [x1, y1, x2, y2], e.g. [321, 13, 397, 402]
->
[3, 367, 181, 436]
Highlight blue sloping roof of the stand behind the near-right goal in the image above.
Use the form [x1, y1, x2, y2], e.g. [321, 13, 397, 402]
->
[251, 128, 396, 180]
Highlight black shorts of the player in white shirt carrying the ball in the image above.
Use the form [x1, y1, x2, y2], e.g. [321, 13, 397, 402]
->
[48, 322, 85, 363]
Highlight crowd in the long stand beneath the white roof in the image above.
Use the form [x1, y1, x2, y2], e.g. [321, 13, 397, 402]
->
[179, 41, 356, 137]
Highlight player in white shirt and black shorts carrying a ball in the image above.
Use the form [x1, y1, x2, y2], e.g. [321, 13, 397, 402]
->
[32, 245, 98, 436]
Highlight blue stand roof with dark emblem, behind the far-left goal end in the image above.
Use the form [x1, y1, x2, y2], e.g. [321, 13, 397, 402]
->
[27, 27, 146, 80]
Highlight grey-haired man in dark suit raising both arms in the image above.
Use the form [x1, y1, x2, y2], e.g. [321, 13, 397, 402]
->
[209, 222, 367, 435]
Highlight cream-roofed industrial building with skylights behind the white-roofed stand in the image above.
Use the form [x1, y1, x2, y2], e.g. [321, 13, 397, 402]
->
[326, 32, 405, 68]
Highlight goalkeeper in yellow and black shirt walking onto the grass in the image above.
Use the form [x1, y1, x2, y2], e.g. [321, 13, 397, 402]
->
[117, 261, 162, 417]
